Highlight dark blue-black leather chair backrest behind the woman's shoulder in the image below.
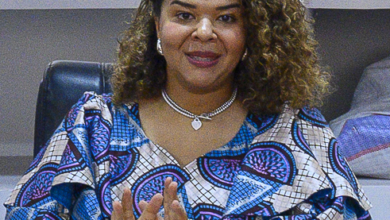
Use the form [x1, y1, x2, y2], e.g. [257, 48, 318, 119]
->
[34, 60, 113, 157]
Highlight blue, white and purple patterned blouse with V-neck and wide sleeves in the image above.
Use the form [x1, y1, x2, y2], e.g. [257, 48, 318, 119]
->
[5, 92, 371, 220]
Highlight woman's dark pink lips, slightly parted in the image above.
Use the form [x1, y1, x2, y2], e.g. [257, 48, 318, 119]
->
[186, 51, 221, 68]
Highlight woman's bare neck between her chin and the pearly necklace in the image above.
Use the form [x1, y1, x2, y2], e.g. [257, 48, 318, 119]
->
[166, 85, 234, 115]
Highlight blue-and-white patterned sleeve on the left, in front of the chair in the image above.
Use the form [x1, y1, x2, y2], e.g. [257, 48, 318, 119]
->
[4, 92, 112, 220]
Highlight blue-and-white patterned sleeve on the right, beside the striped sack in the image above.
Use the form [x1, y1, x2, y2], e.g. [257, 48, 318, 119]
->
[278, 108, 371, 220]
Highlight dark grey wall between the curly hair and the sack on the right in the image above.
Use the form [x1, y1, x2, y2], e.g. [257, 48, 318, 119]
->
[313, 10, 390, 120]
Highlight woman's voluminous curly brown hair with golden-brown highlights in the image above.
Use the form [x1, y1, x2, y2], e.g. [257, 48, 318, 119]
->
[111, 0, 330, 114]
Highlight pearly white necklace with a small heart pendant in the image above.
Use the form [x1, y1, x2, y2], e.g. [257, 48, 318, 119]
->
[162, 88, 237, 131]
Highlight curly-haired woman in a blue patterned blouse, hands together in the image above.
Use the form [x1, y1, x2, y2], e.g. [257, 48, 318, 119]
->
[5, 0, 370, 219]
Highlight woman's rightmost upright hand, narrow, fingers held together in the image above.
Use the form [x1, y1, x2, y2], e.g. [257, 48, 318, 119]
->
[164, 177, 187, 220]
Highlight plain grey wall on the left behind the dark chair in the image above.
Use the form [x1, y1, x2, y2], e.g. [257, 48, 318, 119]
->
[0, 9, 132, 174]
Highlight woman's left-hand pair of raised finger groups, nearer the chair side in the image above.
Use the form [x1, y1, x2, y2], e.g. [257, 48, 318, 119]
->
[111, 189, 163, 220]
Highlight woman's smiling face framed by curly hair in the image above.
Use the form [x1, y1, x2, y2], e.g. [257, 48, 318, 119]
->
[156, 0, 245, 92]
